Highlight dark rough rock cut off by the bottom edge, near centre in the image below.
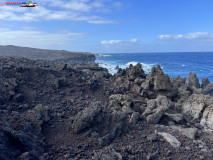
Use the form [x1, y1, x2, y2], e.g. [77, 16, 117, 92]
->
[92, 146, 123, 160]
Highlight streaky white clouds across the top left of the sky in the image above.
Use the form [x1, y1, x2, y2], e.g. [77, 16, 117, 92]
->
[0, 0, 121, 24]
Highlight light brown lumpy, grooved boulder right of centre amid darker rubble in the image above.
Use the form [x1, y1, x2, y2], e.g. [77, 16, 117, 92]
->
[142, 96, 171, 124]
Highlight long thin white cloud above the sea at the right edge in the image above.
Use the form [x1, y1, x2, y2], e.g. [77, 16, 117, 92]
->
[158, 32, 213, 40]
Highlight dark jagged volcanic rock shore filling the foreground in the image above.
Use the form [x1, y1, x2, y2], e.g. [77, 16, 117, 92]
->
[0, 54, 213, 160]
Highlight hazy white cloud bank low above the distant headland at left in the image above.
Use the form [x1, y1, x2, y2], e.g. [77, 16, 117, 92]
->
[0, 28, 87, 49]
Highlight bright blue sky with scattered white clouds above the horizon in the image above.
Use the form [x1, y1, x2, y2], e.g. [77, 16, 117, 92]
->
[0, 0, 213, 53]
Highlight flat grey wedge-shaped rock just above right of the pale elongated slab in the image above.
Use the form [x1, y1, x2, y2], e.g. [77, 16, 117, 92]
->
[171, 126, 198, 139]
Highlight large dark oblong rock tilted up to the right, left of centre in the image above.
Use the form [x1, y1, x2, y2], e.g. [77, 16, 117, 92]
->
[72, 102, 102, 133]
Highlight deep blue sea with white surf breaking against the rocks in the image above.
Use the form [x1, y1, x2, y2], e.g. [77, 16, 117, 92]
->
[96, 52, 213, 83]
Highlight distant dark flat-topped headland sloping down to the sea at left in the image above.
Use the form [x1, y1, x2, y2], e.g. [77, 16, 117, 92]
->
[0, 45, 95, 62]
